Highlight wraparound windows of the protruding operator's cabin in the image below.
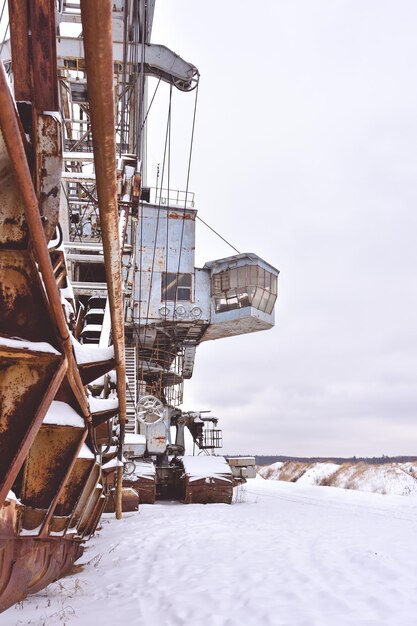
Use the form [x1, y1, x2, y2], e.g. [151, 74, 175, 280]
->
[212, 265, 277, 314]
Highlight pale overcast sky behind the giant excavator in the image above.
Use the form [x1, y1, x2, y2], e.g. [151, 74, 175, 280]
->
[149, 0, 417, 456]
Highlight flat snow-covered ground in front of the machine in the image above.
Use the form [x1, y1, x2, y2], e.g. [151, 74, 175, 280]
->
[0, 478, 417, 626]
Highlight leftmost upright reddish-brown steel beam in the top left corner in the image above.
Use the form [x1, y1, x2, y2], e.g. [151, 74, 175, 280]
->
[9, 0, 32, 102]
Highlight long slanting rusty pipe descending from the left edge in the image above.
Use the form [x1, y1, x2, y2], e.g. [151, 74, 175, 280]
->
[0, 63, 91, 421]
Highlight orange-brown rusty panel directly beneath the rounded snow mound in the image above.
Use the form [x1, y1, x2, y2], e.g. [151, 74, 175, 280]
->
[21, 424, 84, 516]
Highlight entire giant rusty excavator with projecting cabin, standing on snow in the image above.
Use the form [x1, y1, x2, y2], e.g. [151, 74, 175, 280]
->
[0, 0, 278, 611]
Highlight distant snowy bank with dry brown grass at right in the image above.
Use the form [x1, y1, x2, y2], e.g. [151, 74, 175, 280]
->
[259, 461, 417, 496]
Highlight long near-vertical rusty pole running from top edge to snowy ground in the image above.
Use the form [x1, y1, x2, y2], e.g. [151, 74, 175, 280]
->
[80, 0, 126, 519]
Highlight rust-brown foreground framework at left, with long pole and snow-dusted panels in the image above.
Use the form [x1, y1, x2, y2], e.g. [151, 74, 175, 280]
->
[0, 0, 126, 610]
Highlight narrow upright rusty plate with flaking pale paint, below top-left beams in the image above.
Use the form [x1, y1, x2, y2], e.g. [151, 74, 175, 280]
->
[35, 113, 62, 241]
